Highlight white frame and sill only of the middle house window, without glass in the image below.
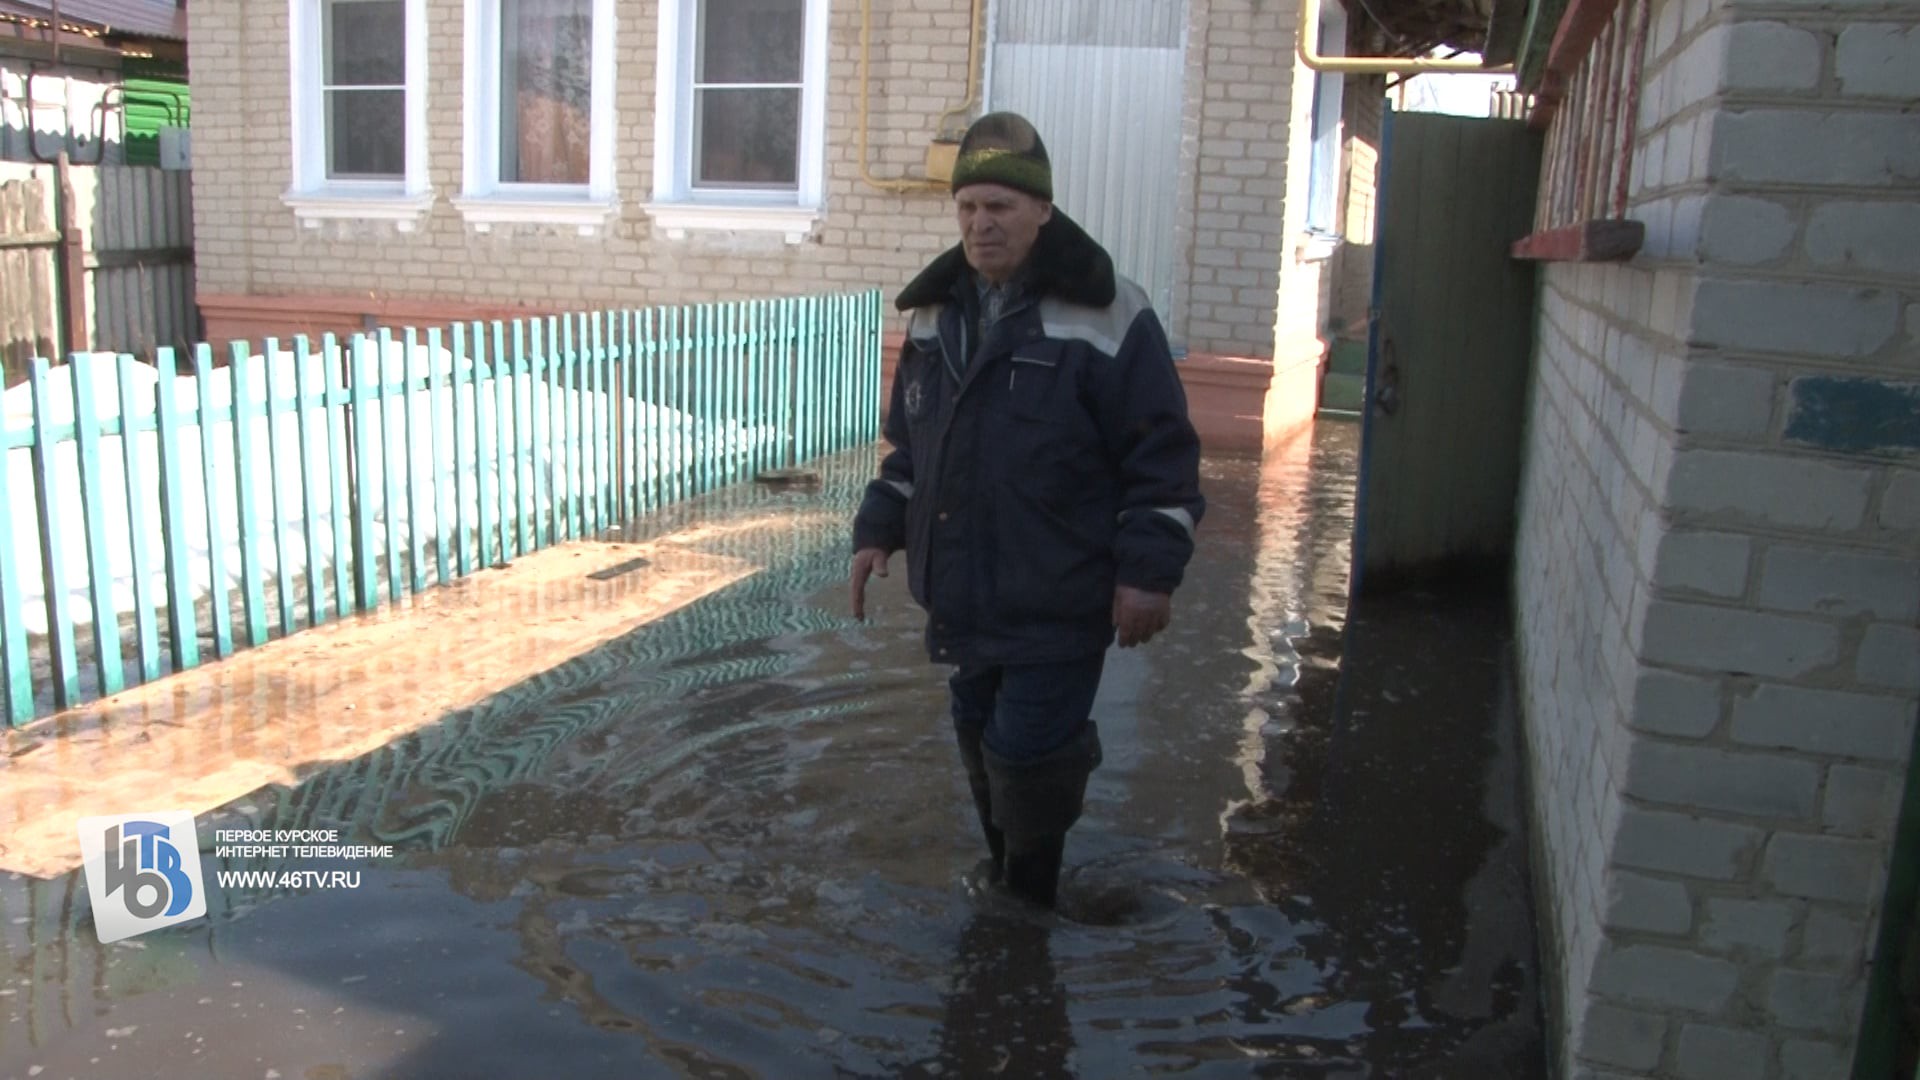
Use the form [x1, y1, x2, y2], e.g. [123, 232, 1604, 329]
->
[453, 0, 620, 236]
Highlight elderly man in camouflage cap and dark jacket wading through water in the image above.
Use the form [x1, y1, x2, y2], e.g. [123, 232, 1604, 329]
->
[851, 113, 1204, 907]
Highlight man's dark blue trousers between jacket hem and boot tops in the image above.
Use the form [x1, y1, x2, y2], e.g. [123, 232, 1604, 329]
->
[947, 651, 1106, 761]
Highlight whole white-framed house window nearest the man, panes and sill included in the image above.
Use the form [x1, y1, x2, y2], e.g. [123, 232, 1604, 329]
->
[647, 0, 828, 242]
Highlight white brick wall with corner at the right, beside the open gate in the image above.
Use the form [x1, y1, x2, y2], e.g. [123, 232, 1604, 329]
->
[1515, 0, 1920, 1080]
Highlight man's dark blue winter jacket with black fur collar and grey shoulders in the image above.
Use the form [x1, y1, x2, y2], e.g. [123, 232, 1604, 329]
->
[854, 208, 1206, 663]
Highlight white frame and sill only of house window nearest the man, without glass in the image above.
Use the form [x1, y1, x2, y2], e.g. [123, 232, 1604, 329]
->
[643, 0, 828, 244]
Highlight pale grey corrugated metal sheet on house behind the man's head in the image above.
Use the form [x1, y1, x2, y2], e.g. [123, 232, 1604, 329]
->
[991, 0, 1187, 329]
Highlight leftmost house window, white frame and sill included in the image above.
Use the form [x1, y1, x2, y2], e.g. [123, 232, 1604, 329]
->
[284, 0, 432, 229]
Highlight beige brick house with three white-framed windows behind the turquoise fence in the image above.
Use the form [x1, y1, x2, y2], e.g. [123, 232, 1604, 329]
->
[190, 0, 1413, 448]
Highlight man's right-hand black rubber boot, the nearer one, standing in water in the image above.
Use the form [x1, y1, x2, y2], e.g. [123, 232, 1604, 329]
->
[979, 721, 1100, 907]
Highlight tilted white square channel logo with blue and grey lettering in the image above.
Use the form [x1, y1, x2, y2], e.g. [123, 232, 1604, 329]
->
[79, 811, 207, 944]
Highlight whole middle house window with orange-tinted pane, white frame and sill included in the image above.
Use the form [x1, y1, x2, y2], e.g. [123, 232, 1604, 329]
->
[453, 0, 614, 233]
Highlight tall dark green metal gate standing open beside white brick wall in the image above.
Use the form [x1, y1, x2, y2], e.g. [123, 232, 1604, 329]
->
[1354, 110, 1540, 594]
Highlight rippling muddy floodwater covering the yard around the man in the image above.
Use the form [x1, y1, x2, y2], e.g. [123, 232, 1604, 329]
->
[0, 417, 1546, 1080]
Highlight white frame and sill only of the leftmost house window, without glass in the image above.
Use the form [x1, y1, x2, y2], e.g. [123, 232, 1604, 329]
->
[280, 0, 434, 233]
